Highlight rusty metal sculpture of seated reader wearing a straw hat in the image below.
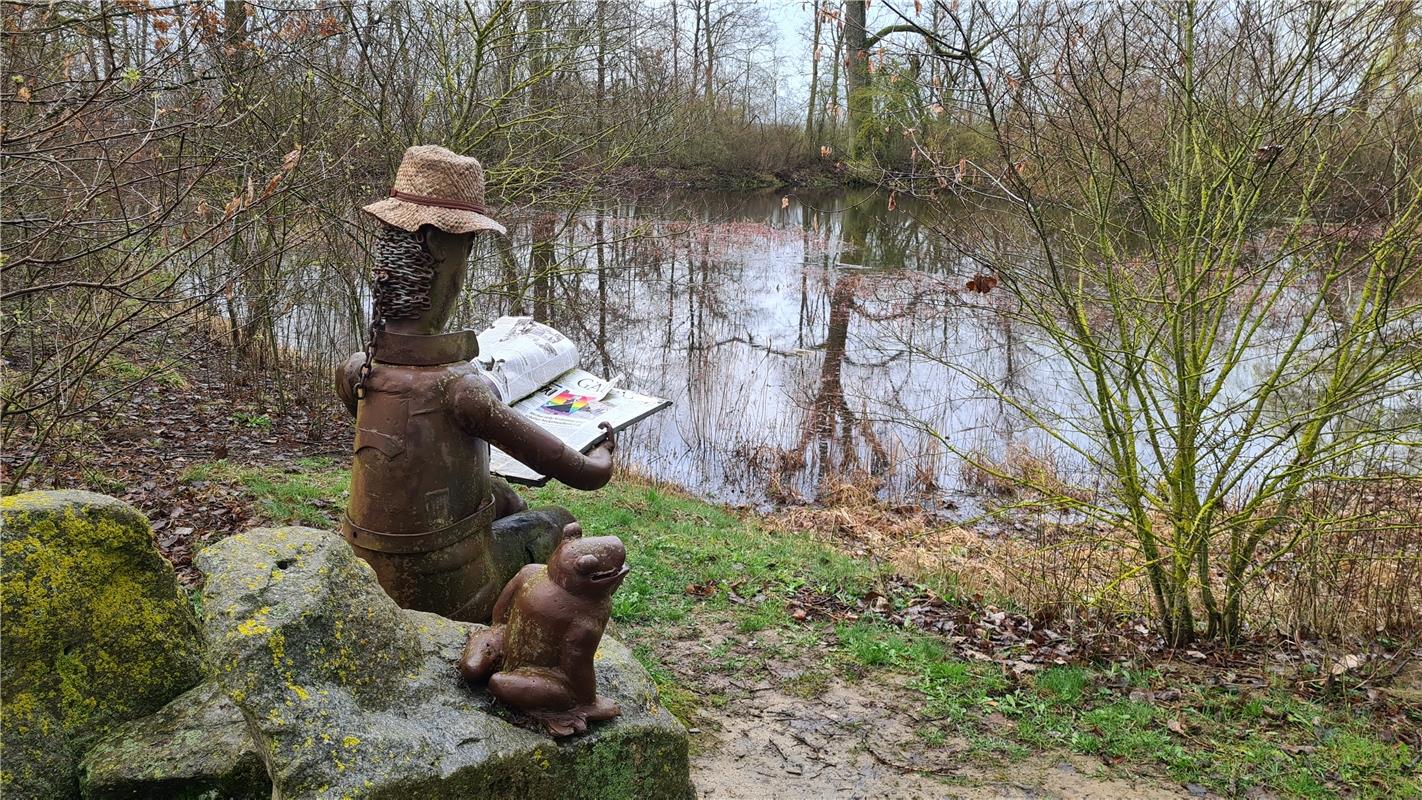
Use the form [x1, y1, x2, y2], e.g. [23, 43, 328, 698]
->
[336, 145, 614, 622]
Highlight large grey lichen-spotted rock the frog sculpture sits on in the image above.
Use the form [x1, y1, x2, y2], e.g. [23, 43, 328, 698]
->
[198, 527, 693, 800]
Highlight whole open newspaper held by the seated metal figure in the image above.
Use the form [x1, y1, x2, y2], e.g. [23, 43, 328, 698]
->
[475, 317, 671, 486]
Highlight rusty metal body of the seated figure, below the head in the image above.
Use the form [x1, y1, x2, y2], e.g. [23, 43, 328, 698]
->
[337, 331, 610, 622]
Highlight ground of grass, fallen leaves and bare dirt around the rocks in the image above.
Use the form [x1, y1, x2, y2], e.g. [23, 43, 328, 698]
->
[6, 355, 1422, 799]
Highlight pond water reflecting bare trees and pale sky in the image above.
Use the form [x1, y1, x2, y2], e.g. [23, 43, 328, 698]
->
[267, 190, 1410, 512]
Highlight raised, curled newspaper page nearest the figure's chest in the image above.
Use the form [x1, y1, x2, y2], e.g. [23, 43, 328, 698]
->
[475, 317, 577, 405]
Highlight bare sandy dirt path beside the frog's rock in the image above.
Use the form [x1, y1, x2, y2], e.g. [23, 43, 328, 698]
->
[658, 624, 1206, 800]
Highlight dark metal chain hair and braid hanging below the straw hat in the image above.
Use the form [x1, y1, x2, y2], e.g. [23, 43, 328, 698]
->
[356, 226, 435, 401]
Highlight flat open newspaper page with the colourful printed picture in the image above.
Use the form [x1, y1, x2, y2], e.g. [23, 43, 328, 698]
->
[489, 369, 671, 486]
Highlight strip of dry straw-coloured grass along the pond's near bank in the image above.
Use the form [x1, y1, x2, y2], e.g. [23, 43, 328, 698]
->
[768, 479, 1422, 638]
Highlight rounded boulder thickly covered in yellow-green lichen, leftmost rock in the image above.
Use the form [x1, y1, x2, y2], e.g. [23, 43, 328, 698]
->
[0, 492, 202, 799]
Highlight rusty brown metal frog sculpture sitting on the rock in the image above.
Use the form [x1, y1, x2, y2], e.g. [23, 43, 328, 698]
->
[459, 523, 627, 736]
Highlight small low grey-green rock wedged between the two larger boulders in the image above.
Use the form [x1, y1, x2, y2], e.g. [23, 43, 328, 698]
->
[80, 681, 272, 800]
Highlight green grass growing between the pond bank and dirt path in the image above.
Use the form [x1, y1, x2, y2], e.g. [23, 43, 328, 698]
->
[183, 471, 1422, 799]
